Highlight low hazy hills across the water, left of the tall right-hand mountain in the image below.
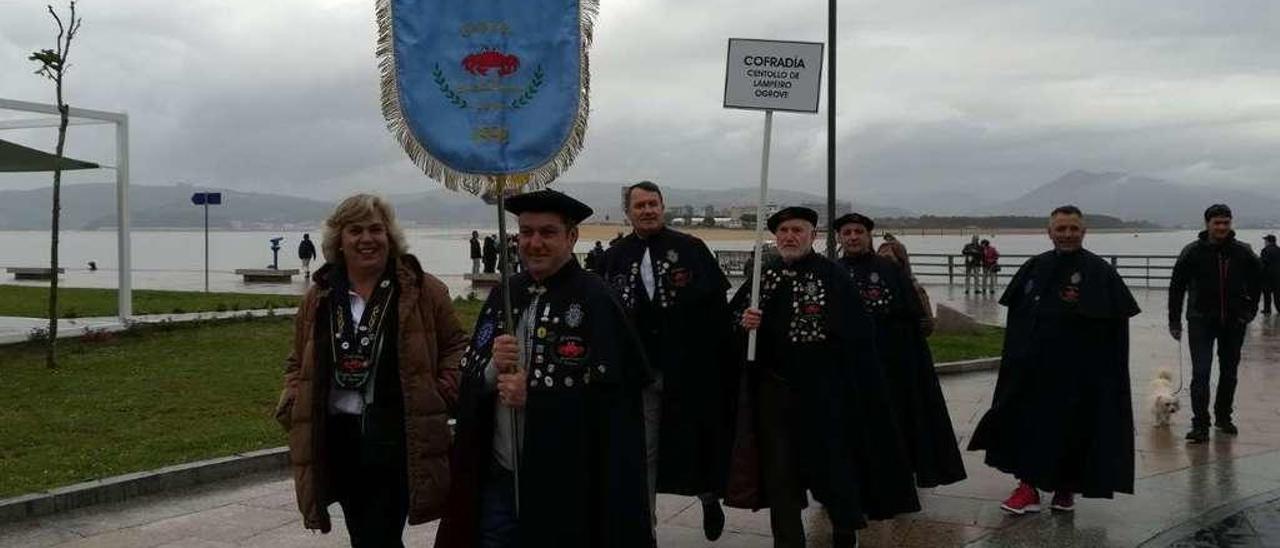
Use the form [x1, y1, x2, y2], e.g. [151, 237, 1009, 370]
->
[0, 183, 913, 230]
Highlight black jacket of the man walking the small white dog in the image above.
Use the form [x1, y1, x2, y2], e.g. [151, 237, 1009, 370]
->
[1169, 232, 1262, 326]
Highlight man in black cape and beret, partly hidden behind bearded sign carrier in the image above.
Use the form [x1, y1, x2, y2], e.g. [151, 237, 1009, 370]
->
[833, 213, 965, 488]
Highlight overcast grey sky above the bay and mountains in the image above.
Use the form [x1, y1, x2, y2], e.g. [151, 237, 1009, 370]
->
[0, 0, 1280, 209]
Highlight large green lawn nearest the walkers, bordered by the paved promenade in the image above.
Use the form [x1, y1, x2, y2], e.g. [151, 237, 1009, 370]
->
[0, 296, 1001, 498]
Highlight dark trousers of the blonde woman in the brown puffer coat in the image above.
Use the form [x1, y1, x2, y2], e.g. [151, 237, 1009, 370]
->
[326, 415, 408, 548]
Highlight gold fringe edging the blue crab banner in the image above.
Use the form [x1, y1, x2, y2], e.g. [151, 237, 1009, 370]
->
[375, 0, 600, 196]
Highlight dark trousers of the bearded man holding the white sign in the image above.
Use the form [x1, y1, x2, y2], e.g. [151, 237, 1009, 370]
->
[758, 371, 858, 548]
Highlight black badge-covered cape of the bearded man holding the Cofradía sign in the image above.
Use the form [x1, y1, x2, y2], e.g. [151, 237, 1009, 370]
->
[727, 252, 920, 527]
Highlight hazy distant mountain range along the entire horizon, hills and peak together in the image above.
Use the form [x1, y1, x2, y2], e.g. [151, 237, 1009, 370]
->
[0, 170, 1280, 230]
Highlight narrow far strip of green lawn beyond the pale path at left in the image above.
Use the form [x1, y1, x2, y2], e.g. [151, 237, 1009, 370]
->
[0, 286, 298, 319]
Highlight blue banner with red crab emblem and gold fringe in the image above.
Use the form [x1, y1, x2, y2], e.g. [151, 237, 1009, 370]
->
[378, 0, 599, 195]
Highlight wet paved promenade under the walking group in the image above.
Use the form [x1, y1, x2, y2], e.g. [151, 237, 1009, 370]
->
[0, 287, 1280, 548]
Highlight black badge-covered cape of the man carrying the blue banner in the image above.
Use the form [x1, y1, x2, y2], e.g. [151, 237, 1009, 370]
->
[435, 260, 652, 548]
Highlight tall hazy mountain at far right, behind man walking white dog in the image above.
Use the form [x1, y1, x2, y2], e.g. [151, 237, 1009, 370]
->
[978, 170, 1280, 227]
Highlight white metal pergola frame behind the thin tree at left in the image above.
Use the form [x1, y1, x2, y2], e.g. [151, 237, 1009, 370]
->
[0, 99, 133, 321]
